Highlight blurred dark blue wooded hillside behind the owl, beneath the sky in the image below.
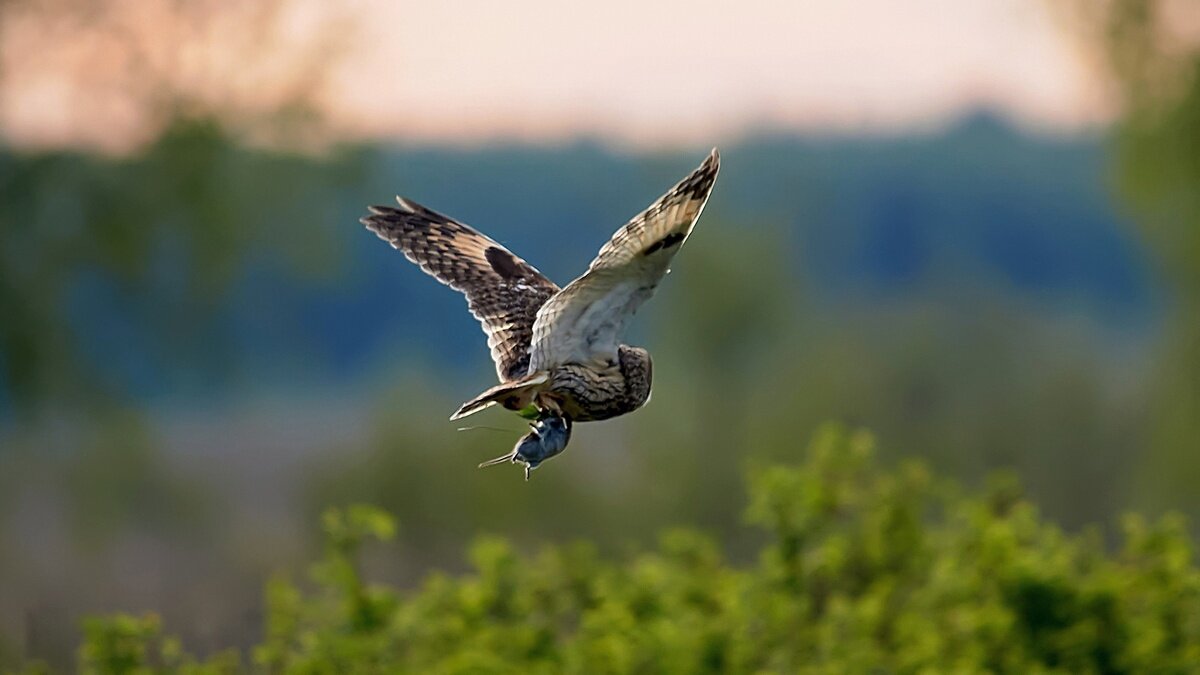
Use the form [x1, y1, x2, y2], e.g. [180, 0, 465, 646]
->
[54, 115, 1157, 396]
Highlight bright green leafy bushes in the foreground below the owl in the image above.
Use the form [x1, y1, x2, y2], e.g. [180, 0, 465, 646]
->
[63, 426, 1200, 673]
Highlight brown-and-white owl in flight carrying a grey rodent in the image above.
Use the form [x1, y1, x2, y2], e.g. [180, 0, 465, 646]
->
[362, 148, 720, 480]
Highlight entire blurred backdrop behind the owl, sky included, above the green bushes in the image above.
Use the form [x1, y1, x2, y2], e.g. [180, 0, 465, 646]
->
[0, 0, 1200, 667]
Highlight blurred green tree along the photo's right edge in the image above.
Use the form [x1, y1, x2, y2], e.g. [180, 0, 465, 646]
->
[1072, 0, 1200, 512]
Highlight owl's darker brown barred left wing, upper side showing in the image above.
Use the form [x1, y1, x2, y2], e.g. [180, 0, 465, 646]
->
[362, 197, 558, 382]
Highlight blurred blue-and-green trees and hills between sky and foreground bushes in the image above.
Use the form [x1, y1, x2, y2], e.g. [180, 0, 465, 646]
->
[0, 0, 1200, 664]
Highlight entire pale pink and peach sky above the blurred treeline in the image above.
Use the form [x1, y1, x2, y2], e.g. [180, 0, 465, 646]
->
[0, 0, 1112, 148]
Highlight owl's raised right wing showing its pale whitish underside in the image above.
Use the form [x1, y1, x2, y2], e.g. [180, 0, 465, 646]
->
[529, 148, 721, 372]
